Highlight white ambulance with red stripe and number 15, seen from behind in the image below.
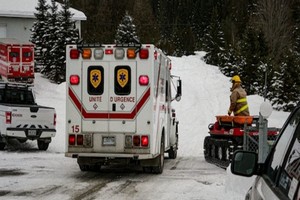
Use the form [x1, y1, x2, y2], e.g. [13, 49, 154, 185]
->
[65, 44, 181, 174]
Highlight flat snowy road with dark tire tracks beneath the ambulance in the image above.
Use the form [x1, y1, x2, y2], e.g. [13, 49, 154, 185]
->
[0, 149, 226, 200]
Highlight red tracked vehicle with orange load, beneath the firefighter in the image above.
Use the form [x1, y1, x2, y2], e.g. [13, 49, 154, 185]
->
[203, 115, 279, 168]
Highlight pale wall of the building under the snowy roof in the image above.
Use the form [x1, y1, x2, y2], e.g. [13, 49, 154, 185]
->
[0, 17, 81, 42]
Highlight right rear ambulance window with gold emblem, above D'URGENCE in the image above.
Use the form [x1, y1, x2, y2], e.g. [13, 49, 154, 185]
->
[114, 66, 131, 95]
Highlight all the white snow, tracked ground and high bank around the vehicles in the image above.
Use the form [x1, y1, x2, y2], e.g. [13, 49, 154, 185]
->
[0, 52, 289, 200]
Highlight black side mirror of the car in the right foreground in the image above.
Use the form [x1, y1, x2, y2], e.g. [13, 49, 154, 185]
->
[231, 150, 258, 177]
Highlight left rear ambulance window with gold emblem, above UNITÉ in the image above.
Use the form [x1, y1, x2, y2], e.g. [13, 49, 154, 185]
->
[87, 66, 104, 95]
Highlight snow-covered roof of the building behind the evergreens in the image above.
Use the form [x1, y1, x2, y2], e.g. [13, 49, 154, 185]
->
[0, 0, 86, 20]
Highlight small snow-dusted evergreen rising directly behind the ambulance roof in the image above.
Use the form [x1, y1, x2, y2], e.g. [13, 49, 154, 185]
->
[115, 11, 139, 44]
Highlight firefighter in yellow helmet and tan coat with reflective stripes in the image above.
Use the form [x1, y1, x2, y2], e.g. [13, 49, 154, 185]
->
[228, 75, 250, 116]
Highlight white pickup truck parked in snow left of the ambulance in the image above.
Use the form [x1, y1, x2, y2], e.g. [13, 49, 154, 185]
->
[0, 82, 56, 150]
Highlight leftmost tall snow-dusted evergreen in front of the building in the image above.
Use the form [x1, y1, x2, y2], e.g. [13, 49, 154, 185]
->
[30, 0, 48, 65]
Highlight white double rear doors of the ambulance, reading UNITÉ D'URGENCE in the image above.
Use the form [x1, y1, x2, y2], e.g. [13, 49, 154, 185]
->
[81, 61, 137, 133]
